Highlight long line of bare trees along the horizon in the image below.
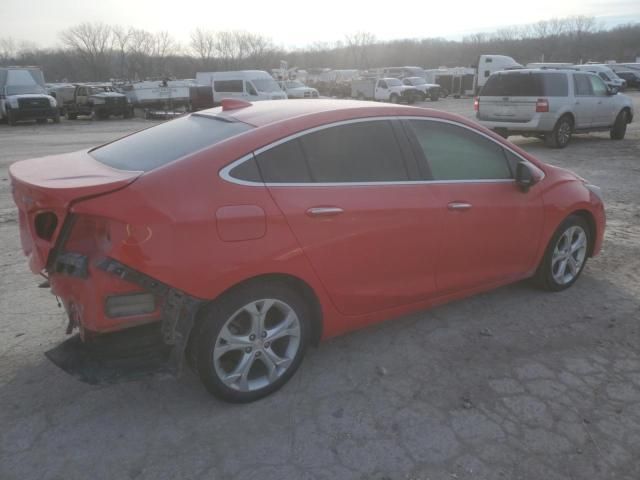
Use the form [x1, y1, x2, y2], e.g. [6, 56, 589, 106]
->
[0, 16, 640, 81]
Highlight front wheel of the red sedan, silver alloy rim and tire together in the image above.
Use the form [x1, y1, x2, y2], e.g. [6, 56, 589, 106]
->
[534, 215, 591, 292]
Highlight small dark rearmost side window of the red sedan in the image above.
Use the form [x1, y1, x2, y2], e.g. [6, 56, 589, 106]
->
[256, 139, 311, 183]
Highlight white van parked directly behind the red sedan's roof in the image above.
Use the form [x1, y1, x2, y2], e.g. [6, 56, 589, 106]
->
[196, 70, 287, 105]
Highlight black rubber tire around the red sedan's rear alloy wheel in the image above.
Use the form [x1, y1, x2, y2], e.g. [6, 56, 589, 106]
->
[191, 282, 311, 403]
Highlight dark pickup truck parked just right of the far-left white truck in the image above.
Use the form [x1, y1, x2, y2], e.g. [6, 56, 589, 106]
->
[55, 84, 133, 120]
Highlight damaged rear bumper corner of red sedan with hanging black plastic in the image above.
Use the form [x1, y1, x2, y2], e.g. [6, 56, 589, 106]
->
[47, 252, 204, 383]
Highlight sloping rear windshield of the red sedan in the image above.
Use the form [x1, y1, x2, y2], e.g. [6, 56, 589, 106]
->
[90, 115, 251, 172]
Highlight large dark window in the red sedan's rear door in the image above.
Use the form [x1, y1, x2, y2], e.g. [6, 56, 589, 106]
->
[300, 120, 408, 182]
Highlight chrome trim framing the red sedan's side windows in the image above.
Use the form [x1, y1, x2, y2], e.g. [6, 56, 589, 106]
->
[219, 115, 545, 188]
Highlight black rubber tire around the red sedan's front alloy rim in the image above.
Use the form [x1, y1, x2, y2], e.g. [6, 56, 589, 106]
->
[533, 215, 592, 292]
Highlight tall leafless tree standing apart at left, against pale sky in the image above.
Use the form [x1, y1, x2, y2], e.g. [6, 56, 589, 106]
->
[60, 23, 114, 80]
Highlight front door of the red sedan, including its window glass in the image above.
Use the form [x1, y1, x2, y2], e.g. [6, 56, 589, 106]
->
[406, 120, 543, 293]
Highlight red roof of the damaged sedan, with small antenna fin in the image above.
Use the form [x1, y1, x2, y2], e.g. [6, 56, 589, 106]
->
[196, 99, 440, 127]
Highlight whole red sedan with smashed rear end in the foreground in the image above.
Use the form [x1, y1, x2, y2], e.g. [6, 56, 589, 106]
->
[10, 100, 605, 402]
